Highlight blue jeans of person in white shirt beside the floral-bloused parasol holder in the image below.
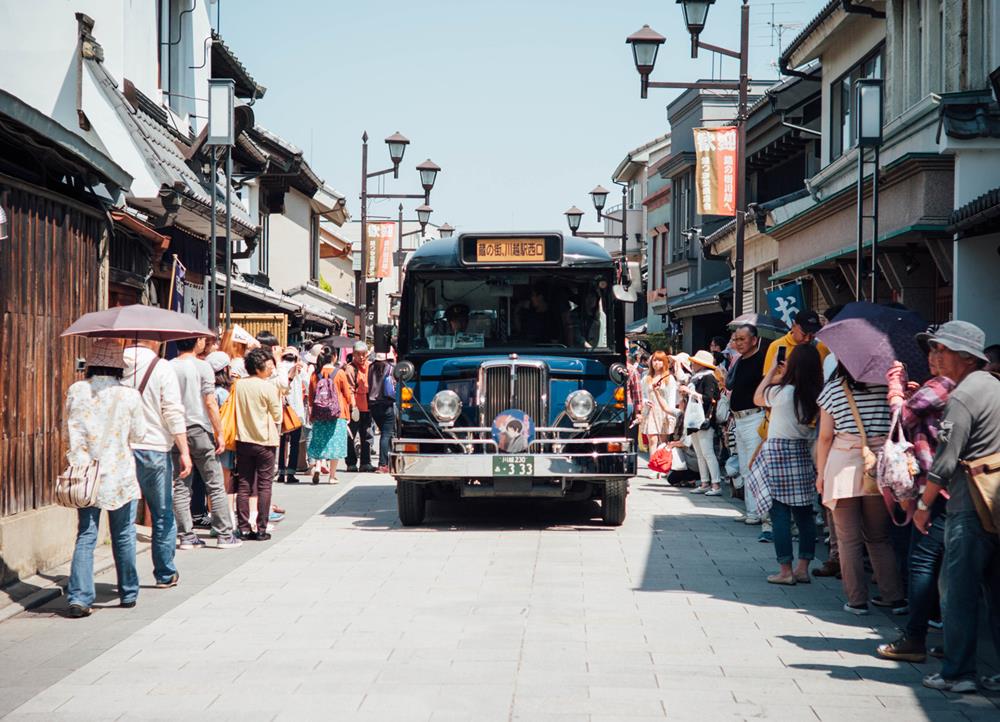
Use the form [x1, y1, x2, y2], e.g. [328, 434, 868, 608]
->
[132, 449, 177, 583]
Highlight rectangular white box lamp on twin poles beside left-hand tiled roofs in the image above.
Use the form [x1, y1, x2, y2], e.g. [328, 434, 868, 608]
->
[205, 78, 236, 330]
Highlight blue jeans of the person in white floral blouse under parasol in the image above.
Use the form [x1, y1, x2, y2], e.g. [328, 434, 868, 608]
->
[66, 501, 139, 607]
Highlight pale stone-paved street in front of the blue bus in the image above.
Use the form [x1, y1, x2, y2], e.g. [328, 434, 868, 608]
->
[0, 475, 1000, 722]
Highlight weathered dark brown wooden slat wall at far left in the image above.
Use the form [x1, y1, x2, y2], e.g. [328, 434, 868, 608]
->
[0, 180, 103, 516]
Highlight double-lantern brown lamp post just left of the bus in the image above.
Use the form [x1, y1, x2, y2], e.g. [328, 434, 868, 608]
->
[354, 132, 441, 340]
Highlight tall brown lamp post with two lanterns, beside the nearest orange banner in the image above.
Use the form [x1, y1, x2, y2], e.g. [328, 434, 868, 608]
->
[625, 0, 750, 318]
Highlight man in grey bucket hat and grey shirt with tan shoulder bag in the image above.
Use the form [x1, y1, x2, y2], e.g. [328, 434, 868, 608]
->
[913, 321, 1000, 692]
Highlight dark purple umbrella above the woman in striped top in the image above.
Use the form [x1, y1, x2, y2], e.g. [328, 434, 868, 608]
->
[816, 301, 930, 384]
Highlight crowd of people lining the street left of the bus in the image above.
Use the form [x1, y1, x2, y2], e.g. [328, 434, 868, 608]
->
[59, 329, 395, 618]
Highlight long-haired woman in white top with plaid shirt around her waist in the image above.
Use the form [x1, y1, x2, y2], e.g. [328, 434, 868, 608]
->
[746, 344, 823, 585]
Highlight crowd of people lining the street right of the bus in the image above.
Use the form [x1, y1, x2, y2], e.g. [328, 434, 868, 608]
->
[627, 308, 1000, 692]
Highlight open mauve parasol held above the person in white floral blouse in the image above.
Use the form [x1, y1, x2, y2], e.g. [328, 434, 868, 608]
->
[60, 303, 215, 341]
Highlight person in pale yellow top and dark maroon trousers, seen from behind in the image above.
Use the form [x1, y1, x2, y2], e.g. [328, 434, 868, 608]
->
[233, 348, 281, 541]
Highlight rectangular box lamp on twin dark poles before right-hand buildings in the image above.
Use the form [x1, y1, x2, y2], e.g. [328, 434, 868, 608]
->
[854, 78, 882, 303]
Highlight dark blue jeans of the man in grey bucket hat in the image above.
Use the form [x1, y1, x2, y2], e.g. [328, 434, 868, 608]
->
[941, 510, 1000, 680]
